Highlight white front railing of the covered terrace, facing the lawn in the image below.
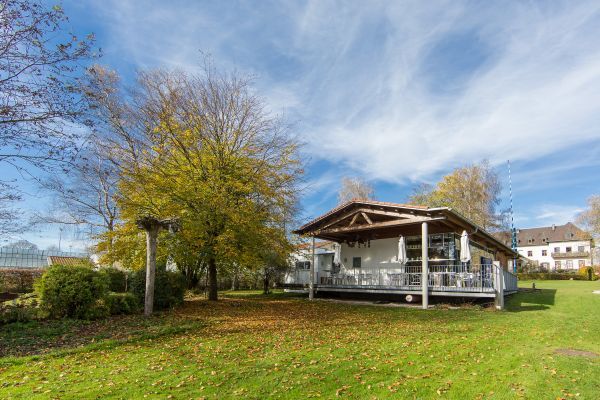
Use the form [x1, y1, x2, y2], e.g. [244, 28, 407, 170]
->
[317, 264, 497, 292]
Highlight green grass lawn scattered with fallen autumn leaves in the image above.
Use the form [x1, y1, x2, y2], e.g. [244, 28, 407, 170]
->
[0, 281, 600, 399]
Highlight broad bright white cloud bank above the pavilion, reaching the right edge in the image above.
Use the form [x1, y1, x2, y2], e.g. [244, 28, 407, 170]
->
[300, 3, 600, 182]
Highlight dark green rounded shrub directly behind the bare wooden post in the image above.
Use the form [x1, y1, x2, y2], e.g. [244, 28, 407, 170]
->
[131, 266, 186, 310]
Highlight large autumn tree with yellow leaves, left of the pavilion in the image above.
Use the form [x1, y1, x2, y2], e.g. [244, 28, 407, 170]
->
[86, 64, 302, 310]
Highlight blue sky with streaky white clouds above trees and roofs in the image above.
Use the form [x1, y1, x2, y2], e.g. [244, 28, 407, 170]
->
[7, 0, 600, 248]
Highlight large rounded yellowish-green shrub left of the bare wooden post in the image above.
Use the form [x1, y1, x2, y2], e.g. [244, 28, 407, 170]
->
[36, 265, 109, 319]
